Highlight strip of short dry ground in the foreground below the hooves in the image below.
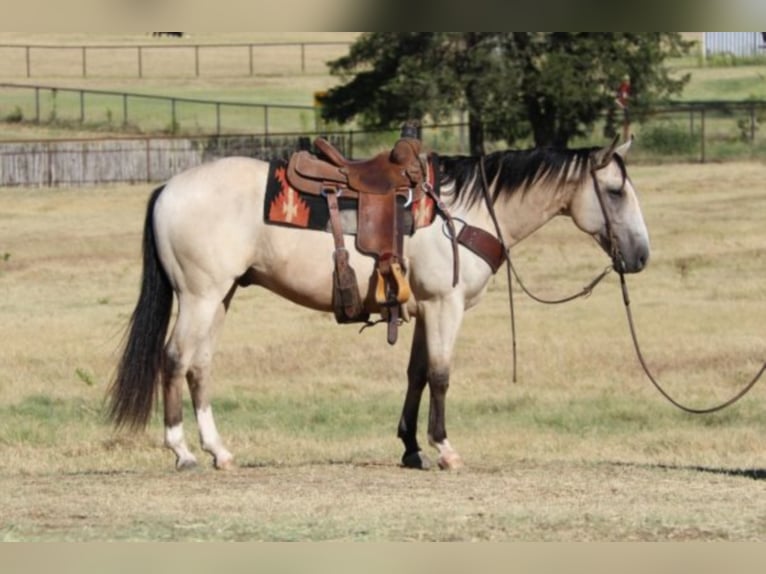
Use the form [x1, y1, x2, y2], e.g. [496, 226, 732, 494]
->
[0, 461, 766, 541]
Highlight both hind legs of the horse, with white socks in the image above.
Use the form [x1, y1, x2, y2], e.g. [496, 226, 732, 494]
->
[163, 294, 232, 469]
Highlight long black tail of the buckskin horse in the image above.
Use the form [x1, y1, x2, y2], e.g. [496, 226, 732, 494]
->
[109, 186, 173, 429]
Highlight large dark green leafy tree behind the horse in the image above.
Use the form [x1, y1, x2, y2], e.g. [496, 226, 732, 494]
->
[322, 32, 690, 154]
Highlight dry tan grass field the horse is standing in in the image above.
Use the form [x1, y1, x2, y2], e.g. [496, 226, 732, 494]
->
[0, 162, 766, 541]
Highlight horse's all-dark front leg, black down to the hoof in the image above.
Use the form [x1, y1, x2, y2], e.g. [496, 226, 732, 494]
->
[397, 318, 431, 470]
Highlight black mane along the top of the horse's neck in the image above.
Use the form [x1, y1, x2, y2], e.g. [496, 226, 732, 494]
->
[439, 147, 599, 206]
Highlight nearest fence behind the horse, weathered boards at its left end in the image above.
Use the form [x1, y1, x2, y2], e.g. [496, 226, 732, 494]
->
[0, 102, 766, 187]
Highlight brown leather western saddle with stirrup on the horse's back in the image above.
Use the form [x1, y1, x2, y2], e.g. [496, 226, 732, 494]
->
[287, 133, 430, 345]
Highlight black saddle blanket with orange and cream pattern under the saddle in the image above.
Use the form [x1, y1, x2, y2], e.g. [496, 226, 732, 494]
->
[263, 160, 439, 235]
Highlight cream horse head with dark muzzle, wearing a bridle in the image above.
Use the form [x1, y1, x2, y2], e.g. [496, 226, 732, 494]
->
[570, 140, 649, 273]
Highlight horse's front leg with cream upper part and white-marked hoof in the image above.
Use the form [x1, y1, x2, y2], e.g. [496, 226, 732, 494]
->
[426, 296, 464, 470]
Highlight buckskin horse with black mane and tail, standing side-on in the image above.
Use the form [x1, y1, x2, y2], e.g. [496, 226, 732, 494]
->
[107, 139, 650, 470]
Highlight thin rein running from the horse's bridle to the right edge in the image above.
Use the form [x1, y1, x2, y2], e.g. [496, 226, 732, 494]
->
[591, 162, 766, 415]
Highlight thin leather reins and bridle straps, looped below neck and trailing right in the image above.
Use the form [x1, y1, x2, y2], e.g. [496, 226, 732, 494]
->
[480, 156, 766, 414]
